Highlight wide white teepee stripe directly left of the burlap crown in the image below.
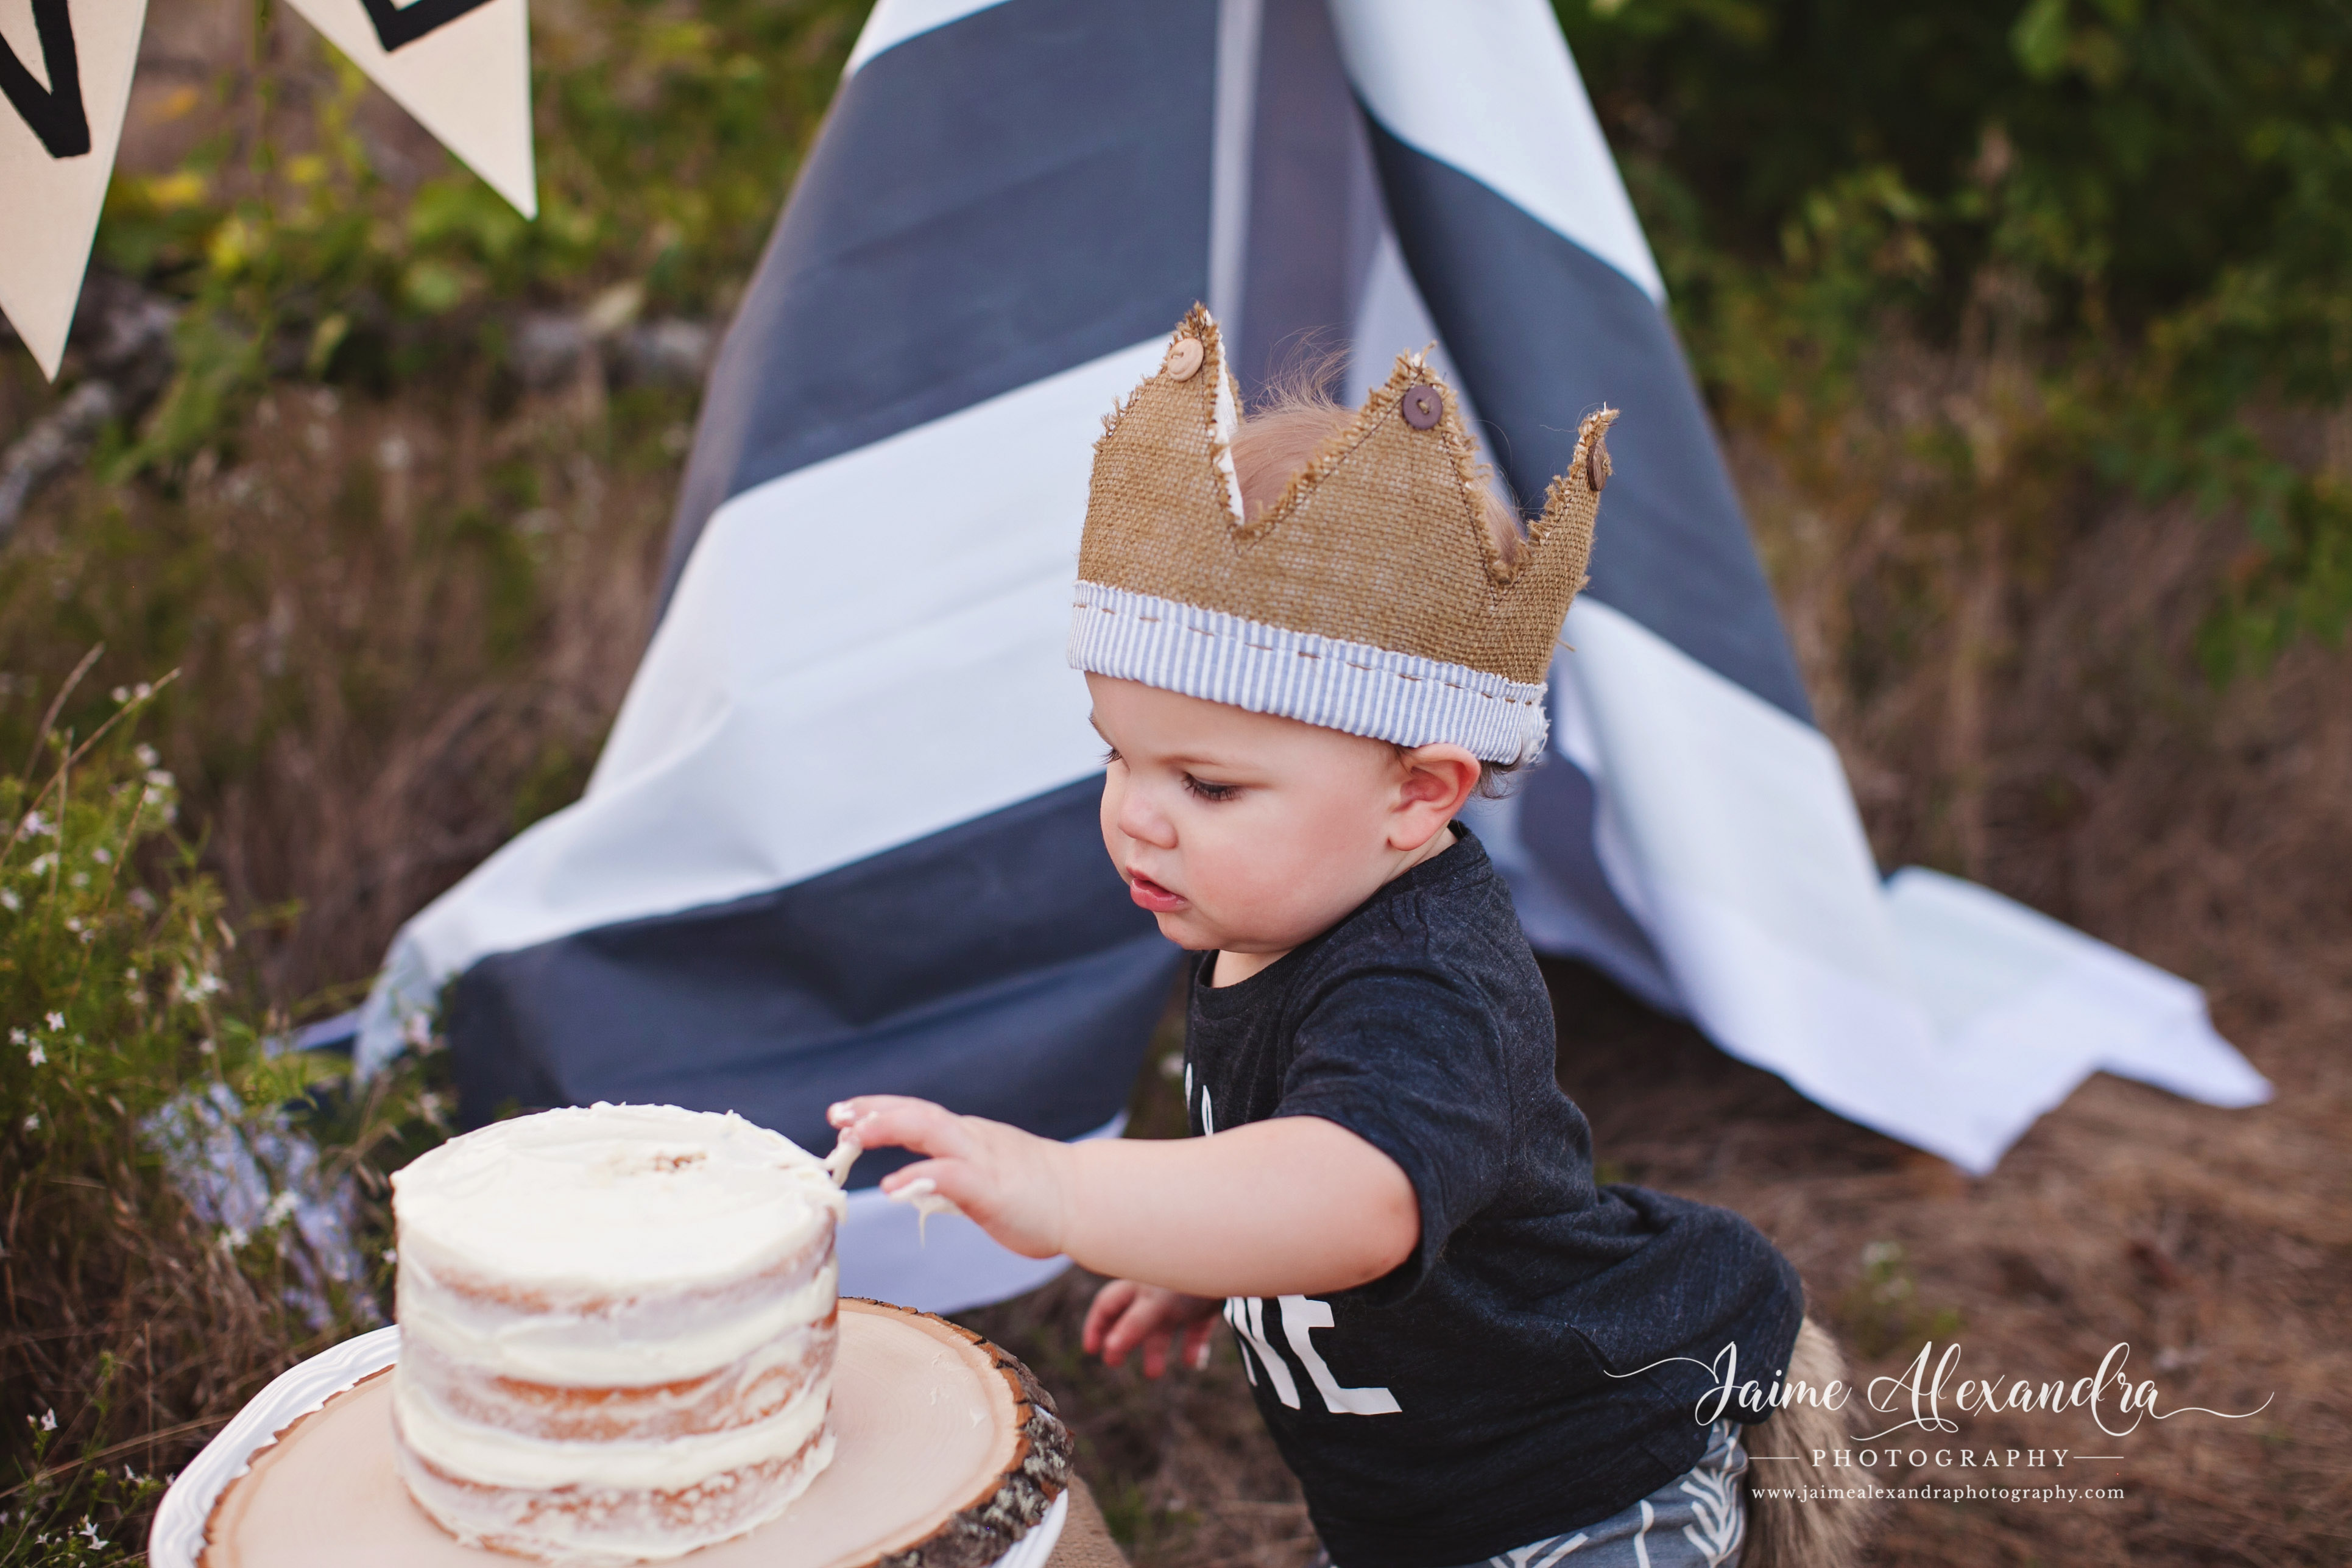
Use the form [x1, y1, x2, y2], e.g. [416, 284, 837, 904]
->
[360, 336, 1167, 1062]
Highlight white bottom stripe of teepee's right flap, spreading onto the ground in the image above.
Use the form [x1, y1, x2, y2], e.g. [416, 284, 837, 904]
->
[1557, 599, 2267, 1173]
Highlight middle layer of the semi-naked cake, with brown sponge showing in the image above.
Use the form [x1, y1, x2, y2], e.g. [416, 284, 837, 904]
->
[400, 1316, 838, 1441]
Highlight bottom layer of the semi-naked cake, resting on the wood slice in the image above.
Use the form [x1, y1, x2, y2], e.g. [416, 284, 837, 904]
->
[395, 1429, 833, 1568]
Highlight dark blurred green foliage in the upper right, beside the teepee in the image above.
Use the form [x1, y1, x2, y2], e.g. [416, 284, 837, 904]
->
[1559, 0, 2352, 675]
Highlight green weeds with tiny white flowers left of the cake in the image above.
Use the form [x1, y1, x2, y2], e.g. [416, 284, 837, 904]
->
[0, 684, 440, 1568]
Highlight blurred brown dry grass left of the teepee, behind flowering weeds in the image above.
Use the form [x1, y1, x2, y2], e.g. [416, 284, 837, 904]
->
[0, 374, 691, 1011]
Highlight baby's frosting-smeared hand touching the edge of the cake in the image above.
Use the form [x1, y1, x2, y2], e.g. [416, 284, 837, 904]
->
[825, 1095, 1068, 1258]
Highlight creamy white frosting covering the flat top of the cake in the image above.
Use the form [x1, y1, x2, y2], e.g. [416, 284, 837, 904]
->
[393, 1105, 844, 1295]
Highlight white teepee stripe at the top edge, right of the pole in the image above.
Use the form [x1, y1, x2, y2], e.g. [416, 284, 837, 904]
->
[1331, 0, 1665, 303]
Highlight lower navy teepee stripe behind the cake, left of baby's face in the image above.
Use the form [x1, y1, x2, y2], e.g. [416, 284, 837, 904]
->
[449, 778, 1178, 1185]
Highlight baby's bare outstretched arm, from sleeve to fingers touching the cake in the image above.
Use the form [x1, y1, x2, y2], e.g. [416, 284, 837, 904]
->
[830, 1095, 1421, 1298]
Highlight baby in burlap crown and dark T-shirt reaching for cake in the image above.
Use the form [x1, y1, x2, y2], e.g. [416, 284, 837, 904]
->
[833, 308, 1825, 1568]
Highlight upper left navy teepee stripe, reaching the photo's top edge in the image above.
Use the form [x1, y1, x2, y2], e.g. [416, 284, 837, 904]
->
[661, 0, 1216, 607]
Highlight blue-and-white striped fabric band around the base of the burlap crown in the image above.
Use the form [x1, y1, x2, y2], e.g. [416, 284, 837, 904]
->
[1070, 581, 1550, 761]
